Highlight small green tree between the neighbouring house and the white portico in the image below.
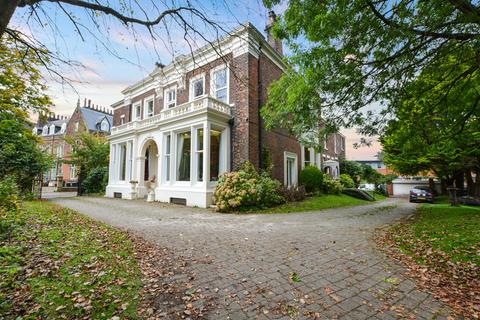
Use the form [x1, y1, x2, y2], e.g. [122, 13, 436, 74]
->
[64, 132, 110, 193]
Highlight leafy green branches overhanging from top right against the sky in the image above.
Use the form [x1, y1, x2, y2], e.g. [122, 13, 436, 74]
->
[264, 0, 480, 134]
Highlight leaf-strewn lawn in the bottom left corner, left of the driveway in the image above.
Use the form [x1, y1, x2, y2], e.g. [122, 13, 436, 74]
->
[0, 201, 141, 319]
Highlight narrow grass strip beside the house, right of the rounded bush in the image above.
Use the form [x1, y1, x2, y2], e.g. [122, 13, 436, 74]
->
[255, 194, 371, 213]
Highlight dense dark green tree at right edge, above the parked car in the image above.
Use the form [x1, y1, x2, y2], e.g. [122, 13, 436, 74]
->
[380, 55, 480, 195]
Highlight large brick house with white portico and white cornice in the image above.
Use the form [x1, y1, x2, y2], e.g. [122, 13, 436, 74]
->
[106, 13, 345, 207]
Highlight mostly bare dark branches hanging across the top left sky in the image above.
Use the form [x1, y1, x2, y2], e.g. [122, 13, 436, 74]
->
[0, 0, 236, 86]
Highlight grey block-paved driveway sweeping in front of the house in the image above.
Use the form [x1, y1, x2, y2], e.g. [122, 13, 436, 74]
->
[52, 197, 449, 319]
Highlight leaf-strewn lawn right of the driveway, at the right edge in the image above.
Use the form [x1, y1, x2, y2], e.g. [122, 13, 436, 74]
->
[377, 204, 480, 319]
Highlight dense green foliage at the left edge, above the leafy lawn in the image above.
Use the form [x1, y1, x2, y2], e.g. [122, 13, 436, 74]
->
[0, 117, 52, 192]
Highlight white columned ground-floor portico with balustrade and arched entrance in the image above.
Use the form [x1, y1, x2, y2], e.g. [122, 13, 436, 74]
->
[106, 96, 231, 207]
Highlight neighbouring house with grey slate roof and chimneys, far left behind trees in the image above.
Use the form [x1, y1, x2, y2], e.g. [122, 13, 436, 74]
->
[32, 99, 113, 188]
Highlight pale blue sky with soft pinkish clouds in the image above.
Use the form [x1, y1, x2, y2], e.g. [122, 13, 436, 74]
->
[9, 0, 380, 160]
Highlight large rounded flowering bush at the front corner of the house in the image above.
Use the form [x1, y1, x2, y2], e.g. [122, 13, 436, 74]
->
[213, 162, 285, 212]
